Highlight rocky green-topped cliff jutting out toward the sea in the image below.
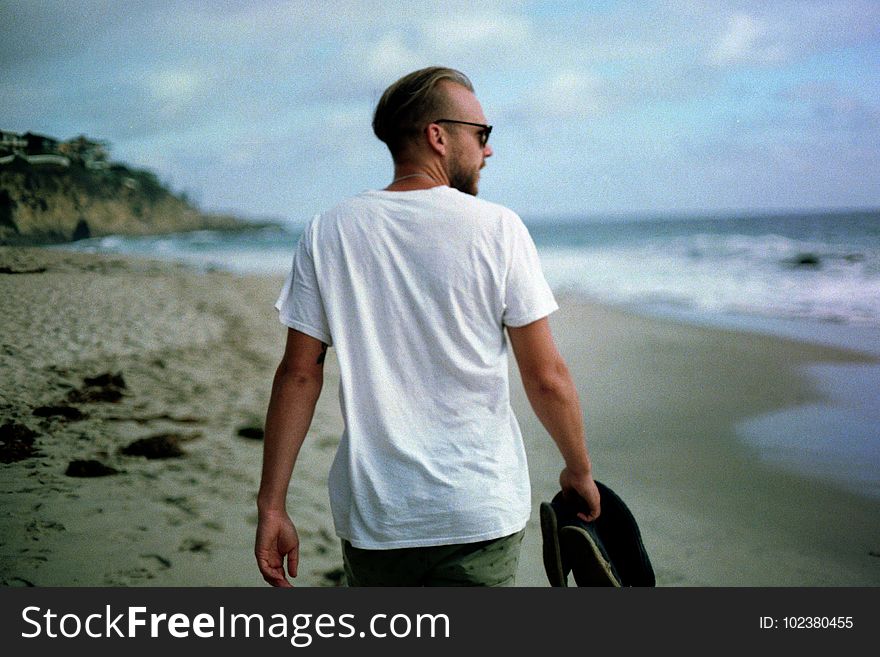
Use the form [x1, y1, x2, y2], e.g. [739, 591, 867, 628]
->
[0, 133, 250, 245]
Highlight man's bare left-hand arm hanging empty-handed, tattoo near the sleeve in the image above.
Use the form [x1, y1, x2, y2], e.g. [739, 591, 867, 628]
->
[254, 329, 327, 586]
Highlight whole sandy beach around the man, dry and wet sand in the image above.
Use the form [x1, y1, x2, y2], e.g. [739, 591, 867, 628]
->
[0, 248, 880, 587]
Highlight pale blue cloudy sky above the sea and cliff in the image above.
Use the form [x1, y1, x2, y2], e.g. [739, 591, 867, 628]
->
[0, 0, 880, 223]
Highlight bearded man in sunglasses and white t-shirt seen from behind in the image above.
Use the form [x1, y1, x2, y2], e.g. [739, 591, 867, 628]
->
[255, 67, 599, 586]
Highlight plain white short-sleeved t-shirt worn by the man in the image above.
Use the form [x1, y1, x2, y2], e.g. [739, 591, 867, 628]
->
[275, 186, 558, 549]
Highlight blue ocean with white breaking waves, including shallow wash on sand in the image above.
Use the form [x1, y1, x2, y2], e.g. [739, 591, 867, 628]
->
[55, 211, 880, 497]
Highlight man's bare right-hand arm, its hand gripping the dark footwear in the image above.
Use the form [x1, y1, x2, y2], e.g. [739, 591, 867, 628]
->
[507, 317, 600, 521]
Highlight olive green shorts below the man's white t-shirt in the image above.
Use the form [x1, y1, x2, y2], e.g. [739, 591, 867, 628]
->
[342, 530, 525, 586]
